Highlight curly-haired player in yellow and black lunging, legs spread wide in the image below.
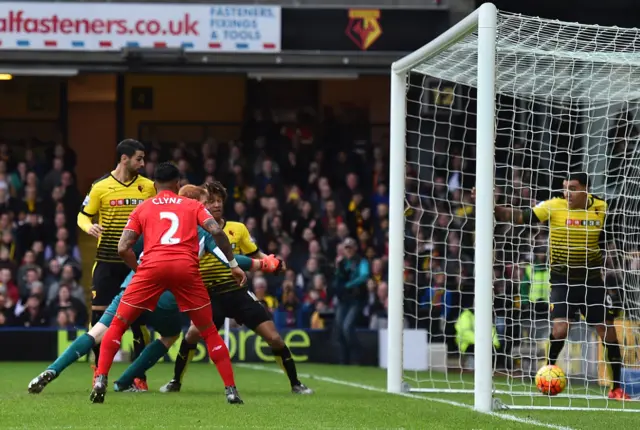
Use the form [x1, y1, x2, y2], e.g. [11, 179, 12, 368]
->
[160, 181, 313, 394]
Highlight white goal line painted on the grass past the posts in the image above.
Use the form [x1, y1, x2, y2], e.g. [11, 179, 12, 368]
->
[235, 363, 575, 430]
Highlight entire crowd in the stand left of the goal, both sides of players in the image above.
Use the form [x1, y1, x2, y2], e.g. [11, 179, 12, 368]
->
[0, 106, 389, 362]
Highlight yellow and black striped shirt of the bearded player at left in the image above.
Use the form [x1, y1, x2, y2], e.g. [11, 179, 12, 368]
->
[80, 173, 156, 263]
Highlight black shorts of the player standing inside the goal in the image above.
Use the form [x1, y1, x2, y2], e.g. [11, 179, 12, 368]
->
[549, 275, 615, 324]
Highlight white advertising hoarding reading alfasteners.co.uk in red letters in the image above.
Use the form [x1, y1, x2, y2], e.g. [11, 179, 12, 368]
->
[0, 2, 281, 53]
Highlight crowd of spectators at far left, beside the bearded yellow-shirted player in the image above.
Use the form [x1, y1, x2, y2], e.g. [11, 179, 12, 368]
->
[0, 141, 88, 328]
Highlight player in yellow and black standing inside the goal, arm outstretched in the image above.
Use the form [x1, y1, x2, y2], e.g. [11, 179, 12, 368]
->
[478, 173, 629, 399]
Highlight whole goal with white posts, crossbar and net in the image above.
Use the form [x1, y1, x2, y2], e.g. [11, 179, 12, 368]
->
[388, 4, 640, 412]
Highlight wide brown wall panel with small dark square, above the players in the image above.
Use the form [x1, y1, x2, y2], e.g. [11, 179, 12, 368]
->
[124, 74, 246, 138]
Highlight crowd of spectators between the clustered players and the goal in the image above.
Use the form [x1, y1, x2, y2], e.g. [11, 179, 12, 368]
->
[144, 108, 389, 361]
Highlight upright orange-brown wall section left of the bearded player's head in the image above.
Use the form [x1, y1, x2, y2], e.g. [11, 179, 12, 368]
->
[67, 74, 117, 193]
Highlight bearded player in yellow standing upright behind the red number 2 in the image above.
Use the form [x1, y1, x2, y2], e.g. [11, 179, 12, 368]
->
[78, 139, 156, 389]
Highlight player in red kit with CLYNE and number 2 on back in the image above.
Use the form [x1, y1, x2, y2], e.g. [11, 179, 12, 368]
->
[90, 163, 246, 403]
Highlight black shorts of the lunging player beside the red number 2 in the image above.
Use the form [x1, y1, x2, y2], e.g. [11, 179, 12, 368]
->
[209, 288, 271, 331]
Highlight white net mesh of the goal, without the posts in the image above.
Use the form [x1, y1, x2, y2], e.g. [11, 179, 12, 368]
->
[404, 13, 640, 410]
